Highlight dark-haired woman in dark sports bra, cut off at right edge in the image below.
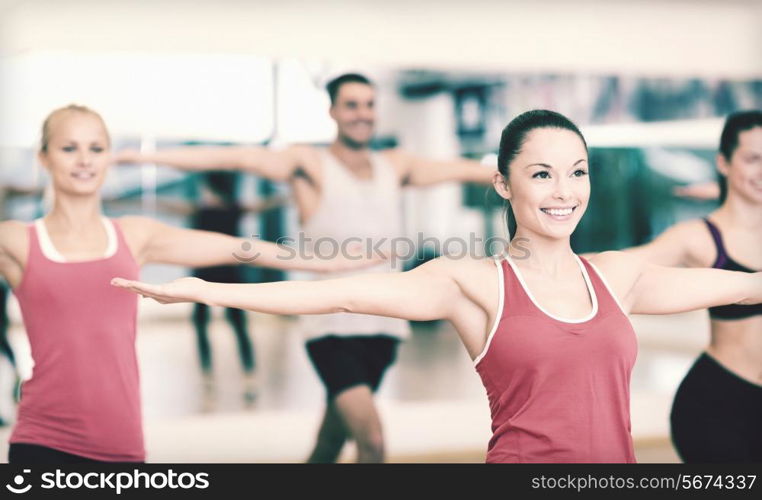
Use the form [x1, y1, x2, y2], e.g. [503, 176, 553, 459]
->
[630, 111, 762, 462]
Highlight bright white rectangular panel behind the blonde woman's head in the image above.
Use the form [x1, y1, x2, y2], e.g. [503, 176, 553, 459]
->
[0, 50, 273, 147]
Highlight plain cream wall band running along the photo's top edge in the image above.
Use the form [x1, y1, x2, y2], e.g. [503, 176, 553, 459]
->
[0, 0, 762, 78]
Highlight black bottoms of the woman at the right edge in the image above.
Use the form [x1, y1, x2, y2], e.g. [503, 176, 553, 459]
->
[670, 353, 762, 463]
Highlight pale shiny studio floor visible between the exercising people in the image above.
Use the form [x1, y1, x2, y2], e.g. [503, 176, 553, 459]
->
[0, 301, 708, 462]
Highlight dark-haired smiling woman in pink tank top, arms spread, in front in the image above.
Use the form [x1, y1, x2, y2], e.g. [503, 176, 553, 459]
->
[113, 111, 762, 462]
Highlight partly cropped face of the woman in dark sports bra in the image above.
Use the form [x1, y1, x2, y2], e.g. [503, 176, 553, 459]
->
[717, 127, 762, 204]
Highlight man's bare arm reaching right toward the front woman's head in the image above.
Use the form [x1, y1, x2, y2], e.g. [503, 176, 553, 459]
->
[392, 151, 495, 186]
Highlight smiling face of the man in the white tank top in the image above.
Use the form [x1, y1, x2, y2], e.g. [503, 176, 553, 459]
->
[330, 82, 376, 149]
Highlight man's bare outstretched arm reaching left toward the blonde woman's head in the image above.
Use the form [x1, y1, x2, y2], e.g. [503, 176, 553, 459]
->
[114, 146, 305, 181]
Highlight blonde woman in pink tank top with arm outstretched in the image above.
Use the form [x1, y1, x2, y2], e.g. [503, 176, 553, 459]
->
[0, 106, 374, 463]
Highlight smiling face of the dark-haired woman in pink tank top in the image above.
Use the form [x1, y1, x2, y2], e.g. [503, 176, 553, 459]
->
[495, 128, 590, 239]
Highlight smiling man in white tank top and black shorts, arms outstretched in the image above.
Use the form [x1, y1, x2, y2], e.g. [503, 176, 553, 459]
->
[117, 74, 493, 462]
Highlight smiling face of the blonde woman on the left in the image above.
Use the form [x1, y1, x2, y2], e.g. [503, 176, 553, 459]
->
[38, 110, 111, 196]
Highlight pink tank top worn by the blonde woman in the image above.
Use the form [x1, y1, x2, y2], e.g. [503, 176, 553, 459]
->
[10, 220, 145, 462]
